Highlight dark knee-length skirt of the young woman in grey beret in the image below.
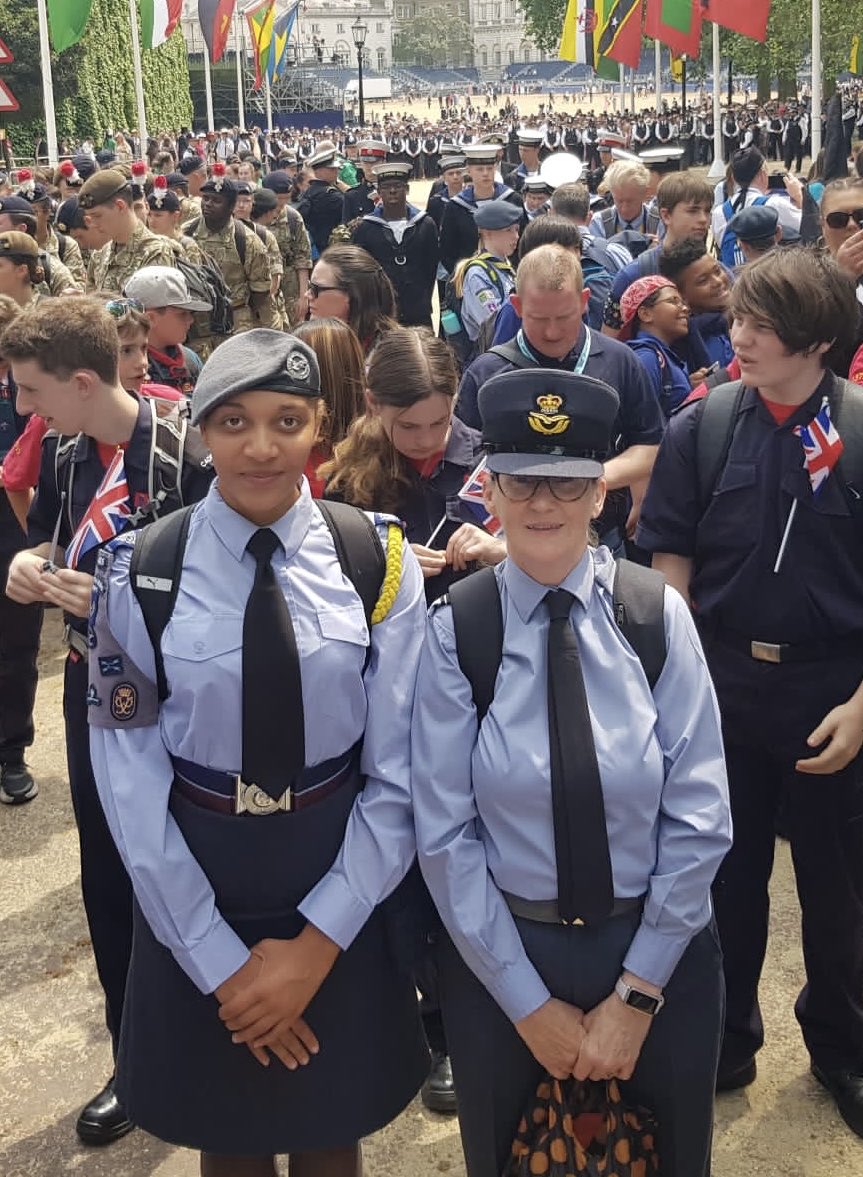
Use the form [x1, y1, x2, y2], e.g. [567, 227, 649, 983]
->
[117, 784, 429, 1156]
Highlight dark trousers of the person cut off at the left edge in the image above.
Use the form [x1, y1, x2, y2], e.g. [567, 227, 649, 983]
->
[0, 550, 42, 764]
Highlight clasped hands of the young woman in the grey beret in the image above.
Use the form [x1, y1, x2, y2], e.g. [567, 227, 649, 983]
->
[215, 924, 339, 1071]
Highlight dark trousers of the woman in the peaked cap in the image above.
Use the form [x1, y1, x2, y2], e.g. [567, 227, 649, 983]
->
[438, 912, 723, 1177]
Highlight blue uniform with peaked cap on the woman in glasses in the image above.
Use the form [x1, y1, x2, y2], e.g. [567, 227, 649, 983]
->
[411, 371, 730, 1177]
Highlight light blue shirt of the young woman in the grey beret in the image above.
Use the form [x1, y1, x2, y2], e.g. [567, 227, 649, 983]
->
[91, 479, 425, 993]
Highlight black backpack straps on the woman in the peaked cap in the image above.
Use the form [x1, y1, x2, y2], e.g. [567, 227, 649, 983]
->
[440, 560, 668, 724]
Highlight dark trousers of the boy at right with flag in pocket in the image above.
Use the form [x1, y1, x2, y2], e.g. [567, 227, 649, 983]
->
[708, 643, 863, 1071]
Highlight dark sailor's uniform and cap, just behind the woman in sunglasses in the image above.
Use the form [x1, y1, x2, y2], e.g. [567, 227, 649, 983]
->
[351, 164, 440, 330]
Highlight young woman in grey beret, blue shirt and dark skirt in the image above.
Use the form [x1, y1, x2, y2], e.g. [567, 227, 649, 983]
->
[88, 330, 429, 1177]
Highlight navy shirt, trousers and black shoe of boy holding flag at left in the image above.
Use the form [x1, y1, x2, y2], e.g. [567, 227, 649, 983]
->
[27, 400, 213, 1143]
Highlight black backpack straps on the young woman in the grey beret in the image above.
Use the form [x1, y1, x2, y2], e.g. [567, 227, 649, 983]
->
[128, 499, 386, 703]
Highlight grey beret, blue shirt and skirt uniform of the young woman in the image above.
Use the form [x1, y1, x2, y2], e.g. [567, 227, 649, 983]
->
[85, 331, 429, 1156]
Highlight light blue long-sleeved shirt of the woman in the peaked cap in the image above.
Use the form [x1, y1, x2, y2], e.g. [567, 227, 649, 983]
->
[412, 548, 731, 1022]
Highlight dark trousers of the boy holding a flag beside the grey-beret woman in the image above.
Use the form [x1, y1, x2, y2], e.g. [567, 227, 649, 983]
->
[64, 653, 132, 1056]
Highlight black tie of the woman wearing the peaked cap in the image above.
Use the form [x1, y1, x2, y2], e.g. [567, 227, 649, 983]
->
[545, 589, 615, 923]
